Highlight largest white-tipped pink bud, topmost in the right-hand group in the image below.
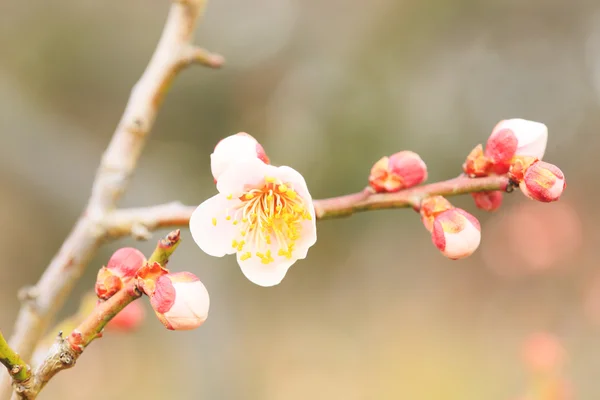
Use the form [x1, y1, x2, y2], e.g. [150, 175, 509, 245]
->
[485, 118, 548, 174]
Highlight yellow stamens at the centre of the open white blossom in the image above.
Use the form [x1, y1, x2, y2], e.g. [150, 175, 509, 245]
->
[227, 177, 312, 264]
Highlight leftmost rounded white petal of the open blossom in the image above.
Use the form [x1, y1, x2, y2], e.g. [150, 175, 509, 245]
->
[190, 195, 241, 257]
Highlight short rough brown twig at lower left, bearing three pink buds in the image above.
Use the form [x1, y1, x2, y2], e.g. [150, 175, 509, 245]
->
[15, 230, 181, 400]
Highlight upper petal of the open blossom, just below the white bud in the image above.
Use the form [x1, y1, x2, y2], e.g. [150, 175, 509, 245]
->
[217, 158, 270, 198]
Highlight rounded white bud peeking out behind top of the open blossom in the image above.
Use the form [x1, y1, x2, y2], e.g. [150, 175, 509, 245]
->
[210, 132, 269, 183]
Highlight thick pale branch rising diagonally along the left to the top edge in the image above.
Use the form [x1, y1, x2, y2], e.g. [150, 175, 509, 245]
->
[0, 0, 222, 398]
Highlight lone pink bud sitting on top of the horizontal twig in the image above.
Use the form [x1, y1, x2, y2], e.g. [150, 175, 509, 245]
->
[369, 151, 427, 192]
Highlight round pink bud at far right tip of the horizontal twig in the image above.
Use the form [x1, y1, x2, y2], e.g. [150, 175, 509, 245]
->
[519, 161, 567, 203]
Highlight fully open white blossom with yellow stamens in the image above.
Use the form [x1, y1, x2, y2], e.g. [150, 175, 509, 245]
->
[190, 158, 317, 286]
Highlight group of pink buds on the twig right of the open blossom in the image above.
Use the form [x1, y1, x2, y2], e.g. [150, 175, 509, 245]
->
[369, 118, 566, 260]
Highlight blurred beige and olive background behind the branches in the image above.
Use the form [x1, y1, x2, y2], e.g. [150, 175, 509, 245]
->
[0, 0, 600, 400]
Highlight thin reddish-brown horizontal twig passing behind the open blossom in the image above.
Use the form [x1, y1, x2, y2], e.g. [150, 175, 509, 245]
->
[106, 176, 508, 237]
